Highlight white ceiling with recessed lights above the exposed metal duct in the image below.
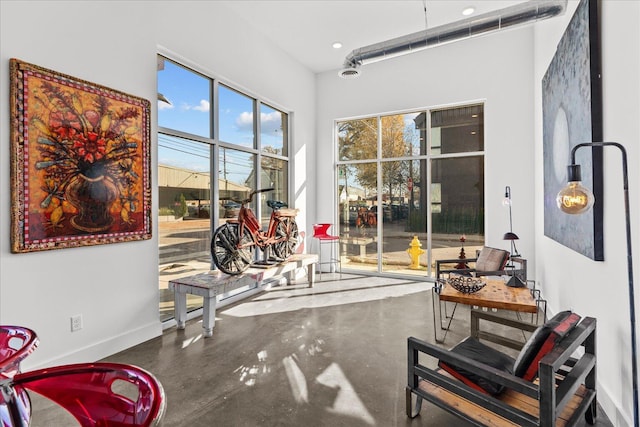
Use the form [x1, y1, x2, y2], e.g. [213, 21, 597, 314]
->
[221, 0, 524, 73]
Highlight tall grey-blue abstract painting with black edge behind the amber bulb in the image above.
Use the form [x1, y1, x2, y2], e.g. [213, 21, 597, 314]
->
[542, 0, 604, 261]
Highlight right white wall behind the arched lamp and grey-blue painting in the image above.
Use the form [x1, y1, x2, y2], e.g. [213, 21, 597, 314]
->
[534, 0, 640, 425]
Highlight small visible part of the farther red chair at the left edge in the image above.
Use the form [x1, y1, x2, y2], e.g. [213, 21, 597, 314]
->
[0, 325, 38, 380]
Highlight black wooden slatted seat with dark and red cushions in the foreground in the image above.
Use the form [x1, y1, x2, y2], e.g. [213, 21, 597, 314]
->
[406, 312, 597, 427]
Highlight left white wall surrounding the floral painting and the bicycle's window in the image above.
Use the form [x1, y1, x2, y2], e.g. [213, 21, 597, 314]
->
[0, 1, 315, 369]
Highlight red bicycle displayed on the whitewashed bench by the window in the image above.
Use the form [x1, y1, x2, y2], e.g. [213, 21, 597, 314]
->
[211, 188, 298, 275]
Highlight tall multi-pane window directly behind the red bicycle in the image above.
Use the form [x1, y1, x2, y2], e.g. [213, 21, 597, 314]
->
[158, 56, 289, 320]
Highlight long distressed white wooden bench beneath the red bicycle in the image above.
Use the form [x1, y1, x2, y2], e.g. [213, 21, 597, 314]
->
[169, 254, 318, 337]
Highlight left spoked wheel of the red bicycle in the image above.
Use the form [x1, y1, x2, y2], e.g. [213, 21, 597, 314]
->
[211, 223, 255, 275]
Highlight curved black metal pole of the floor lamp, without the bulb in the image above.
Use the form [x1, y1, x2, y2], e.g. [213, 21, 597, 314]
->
[571, 142, 638, 427]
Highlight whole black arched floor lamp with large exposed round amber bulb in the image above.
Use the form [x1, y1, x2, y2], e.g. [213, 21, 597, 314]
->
[556, 142, 638, 427]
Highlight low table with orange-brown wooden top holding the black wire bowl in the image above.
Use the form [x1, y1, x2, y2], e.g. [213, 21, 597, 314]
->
[432, 276, 538, 342]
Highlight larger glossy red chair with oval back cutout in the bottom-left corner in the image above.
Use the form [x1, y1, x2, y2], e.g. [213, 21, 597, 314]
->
[0, 363, 166, 427]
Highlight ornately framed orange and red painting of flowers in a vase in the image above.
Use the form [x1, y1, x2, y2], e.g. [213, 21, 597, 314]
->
[10, 59, 151, 253]
